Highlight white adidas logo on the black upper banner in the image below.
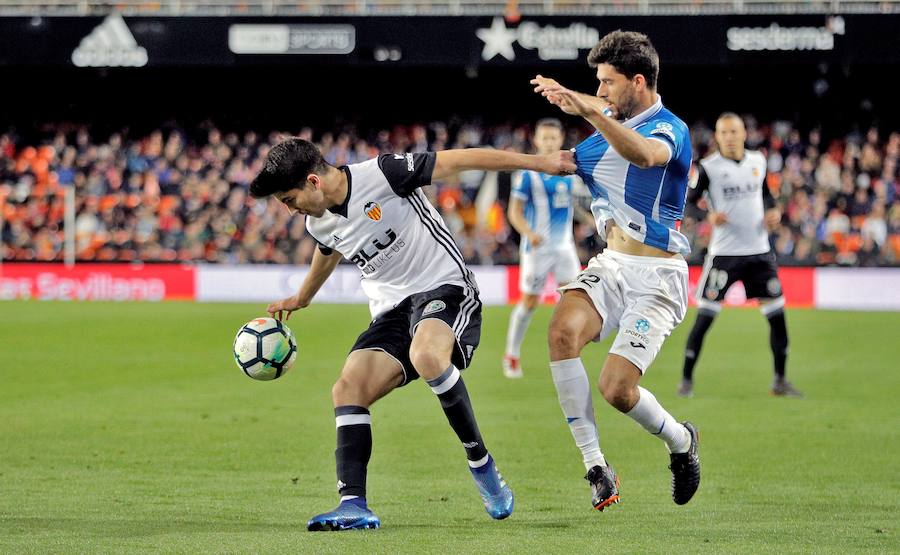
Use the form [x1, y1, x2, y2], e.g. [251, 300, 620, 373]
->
[72, 13, 147, 67]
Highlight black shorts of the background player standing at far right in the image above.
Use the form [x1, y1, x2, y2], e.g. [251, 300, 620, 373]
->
[697, 251, 781, 302]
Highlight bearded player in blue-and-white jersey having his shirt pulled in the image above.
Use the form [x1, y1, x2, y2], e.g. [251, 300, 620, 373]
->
[532, 31, 700, 511]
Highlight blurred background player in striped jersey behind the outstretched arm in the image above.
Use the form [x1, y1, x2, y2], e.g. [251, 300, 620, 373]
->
[503, 118, 581, 378]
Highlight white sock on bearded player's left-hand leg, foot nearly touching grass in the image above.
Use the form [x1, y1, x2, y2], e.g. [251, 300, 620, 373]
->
[550, 358, 606, 470]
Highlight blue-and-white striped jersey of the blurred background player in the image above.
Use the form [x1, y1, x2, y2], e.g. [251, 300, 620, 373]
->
[510, 170, 575, 252]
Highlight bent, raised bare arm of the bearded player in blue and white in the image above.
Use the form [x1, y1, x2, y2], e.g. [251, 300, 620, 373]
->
[531, 75, 670, 168]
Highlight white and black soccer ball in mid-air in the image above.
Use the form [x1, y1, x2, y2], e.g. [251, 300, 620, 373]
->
[234, 318, 297, 380]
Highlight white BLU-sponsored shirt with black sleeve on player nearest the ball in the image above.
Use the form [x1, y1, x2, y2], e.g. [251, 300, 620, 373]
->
[306, 152, 478, 318]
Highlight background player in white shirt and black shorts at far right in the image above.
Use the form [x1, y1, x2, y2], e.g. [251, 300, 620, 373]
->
[678, 112, 803, 397]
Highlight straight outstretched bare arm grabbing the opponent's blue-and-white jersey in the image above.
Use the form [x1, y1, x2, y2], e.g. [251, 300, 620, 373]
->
[431, 148, 575, 179]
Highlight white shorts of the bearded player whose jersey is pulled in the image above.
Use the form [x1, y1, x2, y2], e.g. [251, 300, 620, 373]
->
[560, 249, 688, 374]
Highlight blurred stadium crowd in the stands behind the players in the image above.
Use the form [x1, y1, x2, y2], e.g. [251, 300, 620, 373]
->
[0, 117, 900, 266]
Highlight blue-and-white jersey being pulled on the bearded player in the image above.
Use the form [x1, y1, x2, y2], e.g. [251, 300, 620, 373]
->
[573, 97, 691, 255]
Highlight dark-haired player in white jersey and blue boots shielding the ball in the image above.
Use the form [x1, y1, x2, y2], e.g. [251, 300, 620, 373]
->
[250, 138, 575, 531]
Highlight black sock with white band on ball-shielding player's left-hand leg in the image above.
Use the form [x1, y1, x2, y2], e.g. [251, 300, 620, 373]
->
[334, 405, 372, 497]
